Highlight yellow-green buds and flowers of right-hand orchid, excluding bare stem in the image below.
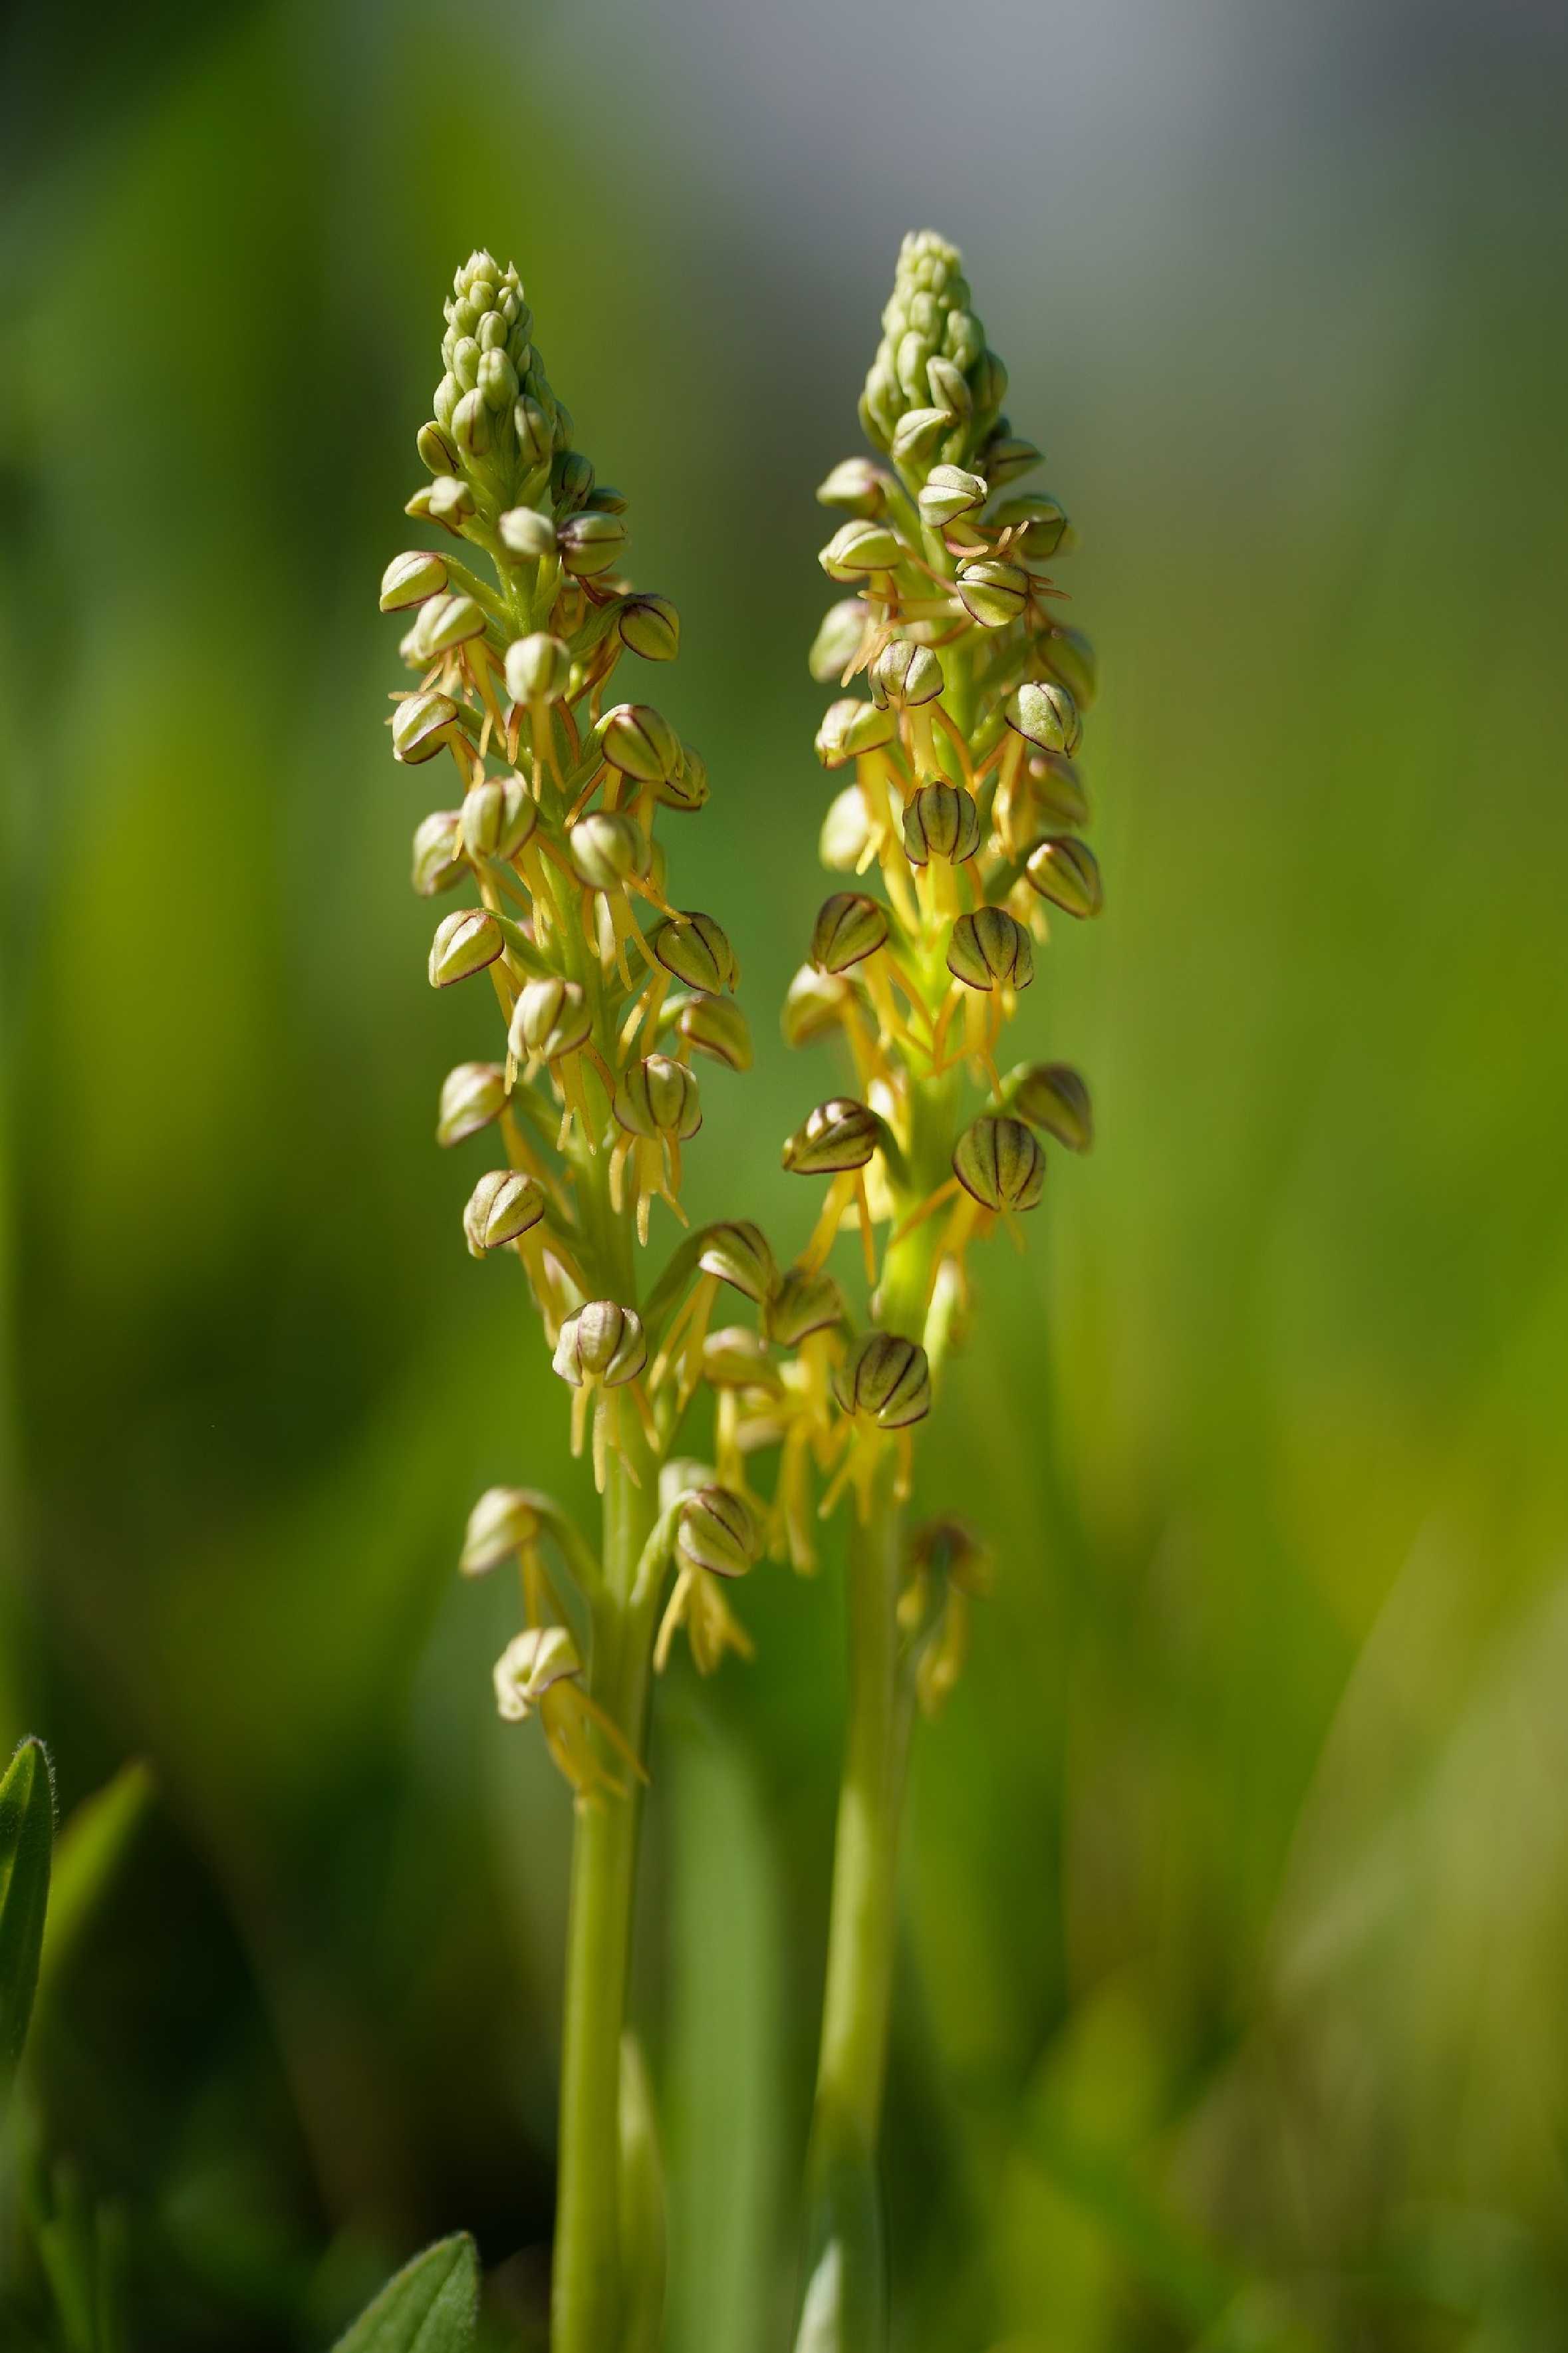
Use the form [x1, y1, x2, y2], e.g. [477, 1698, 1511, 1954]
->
[758, 233, 1102, 1704]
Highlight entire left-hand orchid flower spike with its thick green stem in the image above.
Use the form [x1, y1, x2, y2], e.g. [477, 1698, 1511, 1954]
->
[382, 252, 810, 2353]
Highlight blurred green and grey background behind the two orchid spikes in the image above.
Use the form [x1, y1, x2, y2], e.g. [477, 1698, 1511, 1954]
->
[0, 0, 1568, 2353]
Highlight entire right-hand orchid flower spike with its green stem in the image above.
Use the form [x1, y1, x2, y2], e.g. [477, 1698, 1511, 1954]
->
[784, 233, 1102, 2353]
